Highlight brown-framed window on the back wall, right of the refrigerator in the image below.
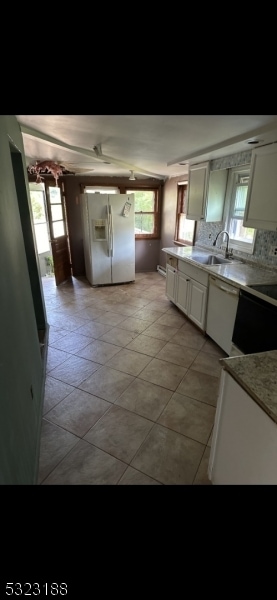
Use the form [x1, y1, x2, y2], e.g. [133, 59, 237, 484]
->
[126, 190, 159, 239]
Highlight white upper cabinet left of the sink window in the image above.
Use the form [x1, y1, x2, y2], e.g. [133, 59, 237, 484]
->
[187, 162, 228, 222]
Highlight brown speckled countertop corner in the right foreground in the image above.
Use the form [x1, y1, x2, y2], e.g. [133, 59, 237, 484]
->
[219, 350, 277, 423]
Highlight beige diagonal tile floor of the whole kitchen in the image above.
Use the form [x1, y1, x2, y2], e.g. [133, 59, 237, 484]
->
[38, 272, 226, 485]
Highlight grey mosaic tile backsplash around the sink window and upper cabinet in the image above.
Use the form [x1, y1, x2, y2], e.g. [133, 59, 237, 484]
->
[195, 151, 277, 268]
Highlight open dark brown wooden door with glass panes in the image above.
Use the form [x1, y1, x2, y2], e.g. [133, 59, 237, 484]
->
[45, 182, 72, 286]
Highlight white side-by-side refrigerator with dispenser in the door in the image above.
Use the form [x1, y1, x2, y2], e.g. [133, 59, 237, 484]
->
[80, 193, 135, 286]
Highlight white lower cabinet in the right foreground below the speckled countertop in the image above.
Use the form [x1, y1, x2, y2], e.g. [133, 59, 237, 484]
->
[208, 369, 277, 485]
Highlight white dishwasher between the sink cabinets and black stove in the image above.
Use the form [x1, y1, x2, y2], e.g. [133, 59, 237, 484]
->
[206, 275, 239, 356]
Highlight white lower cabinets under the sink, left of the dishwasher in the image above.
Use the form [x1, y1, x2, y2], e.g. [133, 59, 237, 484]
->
[166, 256, 208, 331]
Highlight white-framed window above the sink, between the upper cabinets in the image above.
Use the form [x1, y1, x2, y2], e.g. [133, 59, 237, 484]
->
[226, 169, 256, 254]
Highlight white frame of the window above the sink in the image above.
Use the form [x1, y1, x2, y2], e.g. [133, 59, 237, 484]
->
[224, 165, 257, 254]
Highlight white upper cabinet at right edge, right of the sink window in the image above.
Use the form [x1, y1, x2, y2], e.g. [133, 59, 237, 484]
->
[243, 143, 277, 231]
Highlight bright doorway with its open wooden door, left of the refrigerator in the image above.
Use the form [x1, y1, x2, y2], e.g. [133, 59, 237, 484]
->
[29, 181, 72, 286]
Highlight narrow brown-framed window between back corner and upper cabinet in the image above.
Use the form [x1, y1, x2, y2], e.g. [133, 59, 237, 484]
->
[174, 182, 195, 246]
